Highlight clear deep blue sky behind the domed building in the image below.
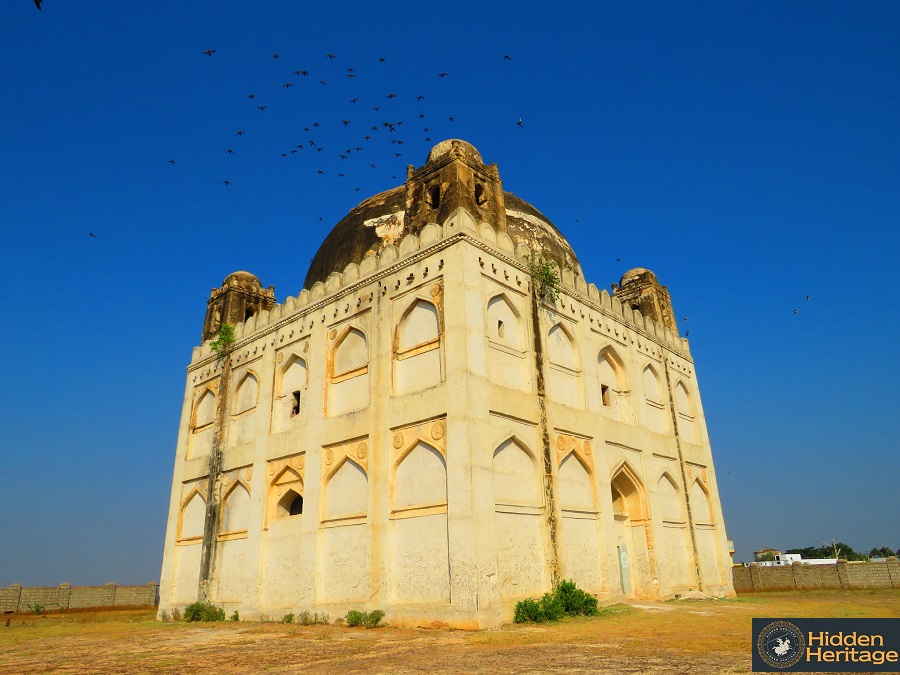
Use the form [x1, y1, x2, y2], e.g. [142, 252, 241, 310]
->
[0, 0, 900, 585]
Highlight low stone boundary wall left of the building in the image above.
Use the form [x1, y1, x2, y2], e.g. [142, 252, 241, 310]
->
[0, 582, 159, 614]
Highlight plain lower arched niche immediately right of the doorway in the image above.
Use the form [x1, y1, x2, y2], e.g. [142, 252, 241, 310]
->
[651, 471, 696, 595]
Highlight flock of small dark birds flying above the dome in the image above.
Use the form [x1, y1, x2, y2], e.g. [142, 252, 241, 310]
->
[166, 48, 525, 192]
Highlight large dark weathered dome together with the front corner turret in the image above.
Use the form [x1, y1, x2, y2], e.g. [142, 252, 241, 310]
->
[304, 139, 581, 288]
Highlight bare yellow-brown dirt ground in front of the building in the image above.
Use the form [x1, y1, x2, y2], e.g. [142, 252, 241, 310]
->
[0, 589, 900, 675]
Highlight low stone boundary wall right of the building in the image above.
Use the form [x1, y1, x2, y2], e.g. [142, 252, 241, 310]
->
[732, 561, 900, 593]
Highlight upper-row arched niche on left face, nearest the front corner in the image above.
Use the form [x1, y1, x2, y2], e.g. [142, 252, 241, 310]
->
[392, 298, 444, 396]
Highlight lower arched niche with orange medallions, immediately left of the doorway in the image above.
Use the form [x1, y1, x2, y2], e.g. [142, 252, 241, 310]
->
[557, 435, 603, 593]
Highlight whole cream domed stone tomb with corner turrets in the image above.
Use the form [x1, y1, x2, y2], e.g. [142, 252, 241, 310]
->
[160, 140, 734, 628]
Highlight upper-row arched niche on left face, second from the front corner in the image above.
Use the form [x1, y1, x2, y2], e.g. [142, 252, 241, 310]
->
[326, 326, 369, 416]
